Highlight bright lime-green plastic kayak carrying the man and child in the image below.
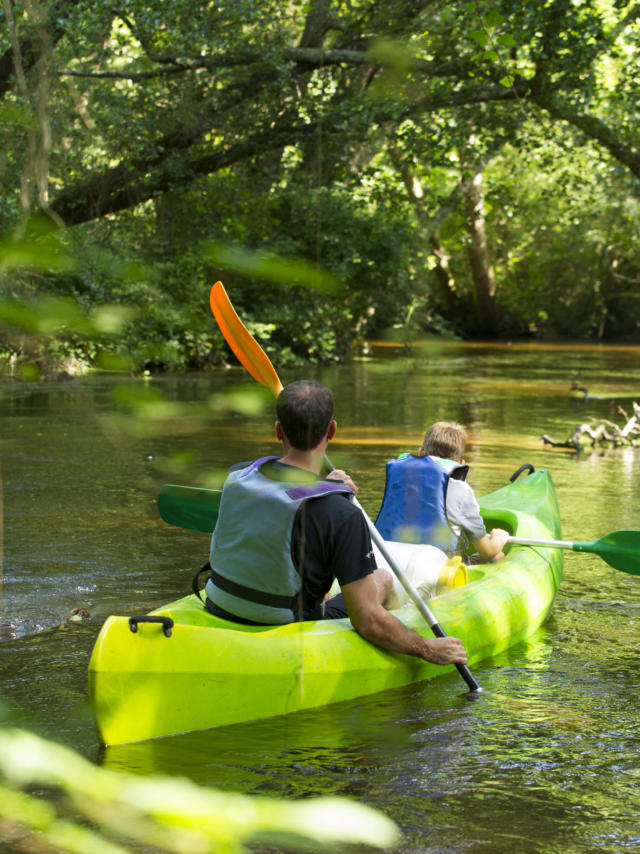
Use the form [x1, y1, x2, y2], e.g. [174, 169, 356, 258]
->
[89, 471, 563, 745]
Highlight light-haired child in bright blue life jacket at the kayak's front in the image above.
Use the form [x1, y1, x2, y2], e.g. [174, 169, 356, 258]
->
[376, 421, 509, 563]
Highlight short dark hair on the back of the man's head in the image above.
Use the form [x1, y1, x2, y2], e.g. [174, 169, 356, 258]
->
[276, 380, 333, 451]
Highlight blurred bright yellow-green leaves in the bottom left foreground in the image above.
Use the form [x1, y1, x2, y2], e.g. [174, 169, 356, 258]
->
[0, 727, 397, 854]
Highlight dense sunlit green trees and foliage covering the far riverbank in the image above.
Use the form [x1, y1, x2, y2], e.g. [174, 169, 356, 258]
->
[0, 0, 640, 370]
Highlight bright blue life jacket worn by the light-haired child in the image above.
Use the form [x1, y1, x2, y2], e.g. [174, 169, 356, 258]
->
[376, 454, 469, 552]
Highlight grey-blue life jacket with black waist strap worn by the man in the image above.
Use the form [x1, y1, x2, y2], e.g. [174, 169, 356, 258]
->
[205, 457, 352, 625]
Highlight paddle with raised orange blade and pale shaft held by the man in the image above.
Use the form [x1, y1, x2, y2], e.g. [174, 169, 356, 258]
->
[209, 282, 482, 692]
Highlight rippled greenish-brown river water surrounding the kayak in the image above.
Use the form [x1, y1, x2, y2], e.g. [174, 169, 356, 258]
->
[0, 342, 640, 852]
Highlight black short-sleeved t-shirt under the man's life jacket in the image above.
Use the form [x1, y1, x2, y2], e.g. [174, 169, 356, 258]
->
[220, 460, 376, 619]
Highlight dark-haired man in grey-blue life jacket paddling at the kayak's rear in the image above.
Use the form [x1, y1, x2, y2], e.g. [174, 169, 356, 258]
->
[205, 380, 467, 664]
